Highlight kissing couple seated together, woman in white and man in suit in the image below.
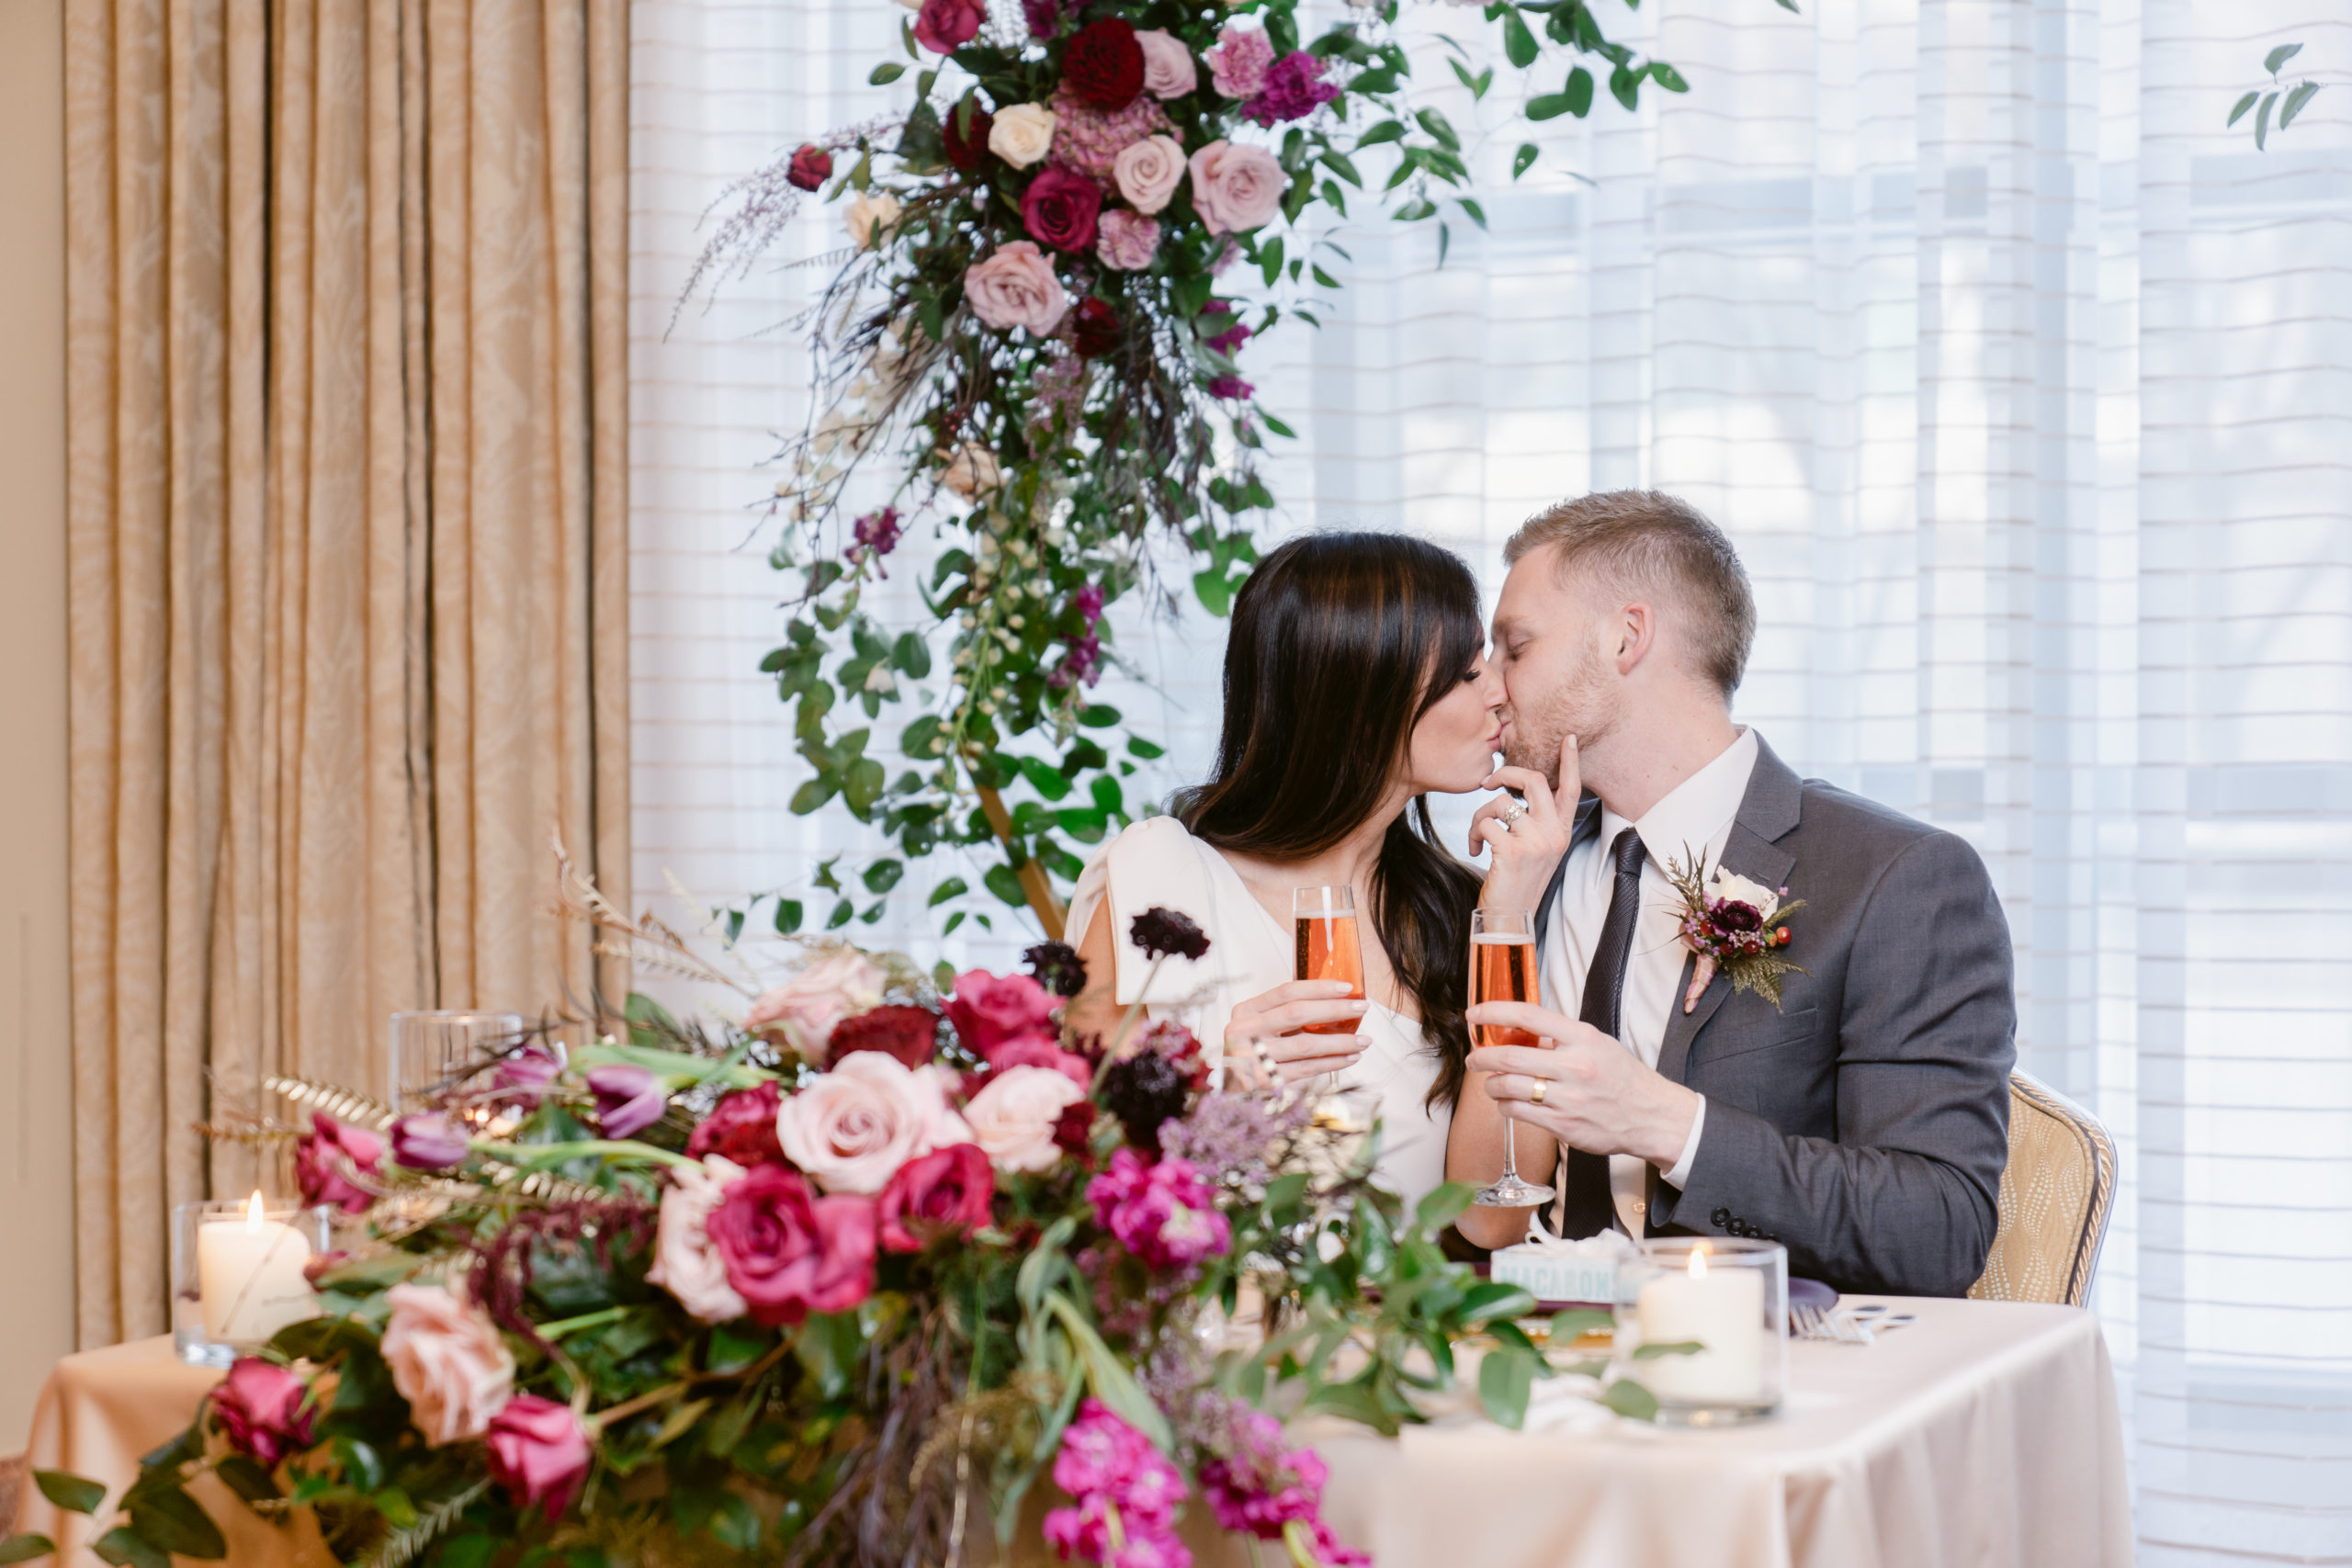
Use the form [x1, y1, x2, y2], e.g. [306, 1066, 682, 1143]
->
[1068, 491, 2016, 1295]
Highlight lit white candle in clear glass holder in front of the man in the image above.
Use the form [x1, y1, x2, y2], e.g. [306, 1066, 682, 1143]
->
[1616, 1236, 1788, 1427]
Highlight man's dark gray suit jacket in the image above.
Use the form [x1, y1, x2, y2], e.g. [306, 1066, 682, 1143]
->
[1536, 736, 2018, 1295]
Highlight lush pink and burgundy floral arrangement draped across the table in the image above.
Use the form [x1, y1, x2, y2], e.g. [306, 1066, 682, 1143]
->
[0, 905, 1674, 1568]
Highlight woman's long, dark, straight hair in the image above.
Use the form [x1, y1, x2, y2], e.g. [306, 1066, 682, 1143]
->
[1171, 534, 1487, 1105]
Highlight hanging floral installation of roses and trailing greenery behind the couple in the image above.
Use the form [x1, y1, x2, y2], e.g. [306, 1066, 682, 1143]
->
[687, 0, 1687, 936]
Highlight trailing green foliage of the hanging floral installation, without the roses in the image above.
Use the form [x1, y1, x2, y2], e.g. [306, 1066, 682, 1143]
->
[724, 0, 1687, 933]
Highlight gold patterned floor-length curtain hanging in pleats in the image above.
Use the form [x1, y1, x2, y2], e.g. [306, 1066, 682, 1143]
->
[66, 0, 628, 1345]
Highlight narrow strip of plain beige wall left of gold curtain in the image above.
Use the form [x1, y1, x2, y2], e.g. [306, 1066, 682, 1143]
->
[0, 0, 73, 1453]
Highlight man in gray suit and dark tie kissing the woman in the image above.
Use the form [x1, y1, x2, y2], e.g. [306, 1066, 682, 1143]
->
[1461, 491, 2016, 1295]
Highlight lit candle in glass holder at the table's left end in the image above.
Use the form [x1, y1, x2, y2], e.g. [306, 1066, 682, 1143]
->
[172, 1192, 334, 1366]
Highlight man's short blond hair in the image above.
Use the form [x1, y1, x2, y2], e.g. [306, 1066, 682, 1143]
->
[1503, 489, 1757, 698]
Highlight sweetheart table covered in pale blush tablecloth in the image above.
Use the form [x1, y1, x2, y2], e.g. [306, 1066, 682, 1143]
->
[18, 1298, 2131, 1568]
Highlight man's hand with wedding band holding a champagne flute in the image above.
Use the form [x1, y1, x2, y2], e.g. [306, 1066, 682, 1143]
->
[1470, 1001, 1698, 1170]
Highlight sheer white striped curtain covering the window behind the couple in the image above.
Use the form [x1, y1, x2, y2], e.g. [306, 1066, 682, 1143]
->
[633, 0, 2352, 1563]
